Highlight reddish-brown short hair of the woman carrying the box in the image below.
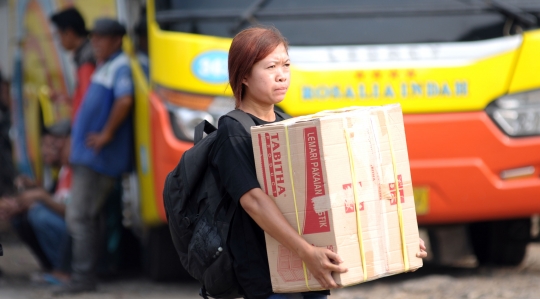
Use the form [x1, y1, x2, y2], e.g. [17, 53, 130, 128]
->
[229, 26, 288, 108]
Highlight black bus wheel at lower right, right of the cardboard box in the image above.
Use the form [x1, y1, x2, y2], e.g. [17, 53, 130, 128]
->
[469, 218, 531, 266]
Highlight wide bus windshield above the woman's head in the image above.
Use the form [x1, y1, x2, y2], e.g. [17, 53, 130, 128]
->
[156, 0, 540, 45]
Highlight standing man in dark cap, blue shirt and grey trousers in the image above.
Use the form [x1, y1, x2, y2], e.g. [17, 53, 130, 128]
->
[55, 18, 133, 294]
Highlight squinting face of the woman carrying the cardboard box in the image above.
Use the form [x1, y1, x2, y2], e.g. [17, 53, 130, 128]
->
[242, 44, 291, 105]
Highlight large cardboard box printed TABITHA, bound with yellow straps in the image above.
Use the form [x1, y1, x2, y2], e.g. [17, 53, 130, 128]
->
[251, 105, 422, 293]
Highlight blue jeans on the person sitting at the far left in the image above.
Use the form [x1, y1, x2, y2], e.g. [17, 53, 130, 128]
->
[28, 203, 69, 269]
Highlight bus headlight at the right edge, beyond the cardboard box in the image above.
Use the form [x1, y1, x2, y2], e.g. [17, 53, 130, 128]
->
[487, 90, 540, 137]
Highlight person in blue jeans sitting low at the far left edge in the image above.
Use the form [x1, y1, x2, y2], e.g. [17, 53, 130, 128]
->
[0, 120, 71, 284]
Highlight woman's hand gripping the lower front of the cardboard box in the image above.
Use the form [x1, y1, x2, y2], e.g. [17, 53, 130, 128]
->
[300, 247, 348, 289]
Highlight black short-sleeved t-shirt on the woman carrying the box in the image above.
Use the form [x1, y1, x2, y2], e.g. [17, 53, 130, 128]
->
[211, 114, 328, 299]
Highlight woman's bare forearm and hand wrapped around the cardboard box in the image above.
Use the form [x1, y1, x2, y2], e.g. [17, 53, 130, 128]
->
[240, 188, 347, 289]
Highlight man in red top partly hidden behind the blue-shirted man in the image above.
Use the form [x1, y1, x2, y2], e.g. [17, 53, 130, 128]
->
[51, 7, 96, 121]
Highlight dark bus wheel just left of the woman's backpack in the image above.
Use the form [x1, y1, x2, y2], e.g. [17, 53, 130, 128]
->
[145, 225, 190, 281]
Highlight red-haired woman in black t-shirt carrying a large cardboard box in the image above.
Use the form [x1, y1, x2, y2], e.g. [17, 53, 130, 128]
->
[211, 27, 427, 299]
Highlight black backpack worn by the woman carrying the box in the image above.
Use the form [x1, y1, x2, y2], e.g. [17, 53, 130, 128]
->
[163, 110, 290, 299]
